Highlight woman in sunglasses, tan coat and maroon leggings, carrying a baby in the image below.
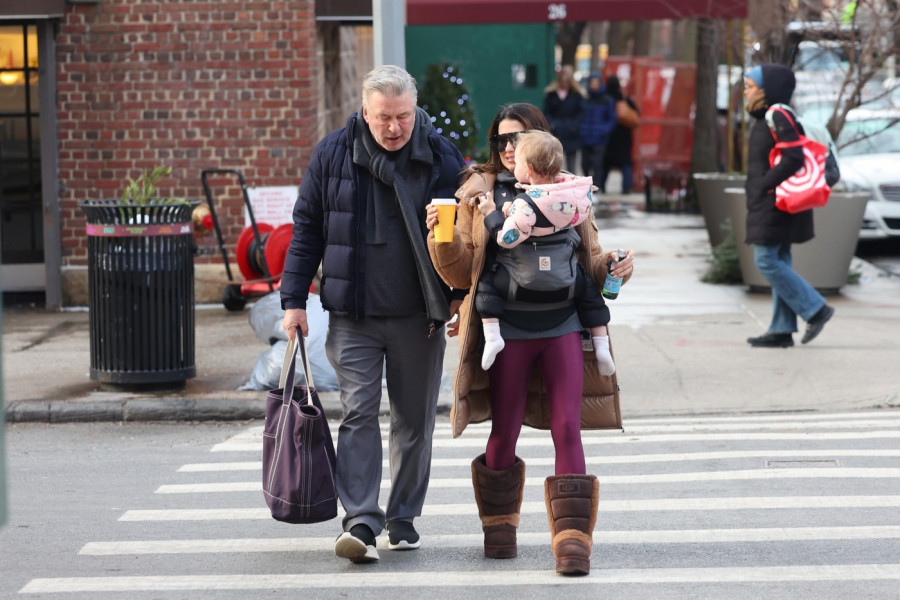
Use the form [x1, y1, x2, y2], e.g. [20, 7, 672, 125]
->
[426, 103, 634, 574]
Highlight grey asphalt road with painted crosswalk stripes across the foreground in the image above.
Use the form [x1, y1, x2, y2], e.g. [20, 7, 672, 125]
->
[0, 410, 900, 600]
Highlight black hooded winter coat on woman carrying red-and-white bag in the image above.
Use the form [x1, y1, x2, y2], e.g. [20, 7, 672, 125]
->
[744, 64, 814, 245]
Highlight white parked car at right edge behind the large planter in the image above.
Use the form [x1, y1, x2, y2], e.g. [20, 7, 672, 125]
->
[837, 109, 900, 240]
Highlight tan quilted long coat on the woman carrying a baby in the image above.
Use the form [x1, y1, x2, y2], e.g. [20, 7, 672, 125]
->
[428, 174, 622, 437]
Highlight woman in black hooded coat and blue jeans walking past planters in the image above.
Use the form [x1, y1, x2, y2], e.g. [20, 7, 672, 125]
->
[744, 64, 834, 348]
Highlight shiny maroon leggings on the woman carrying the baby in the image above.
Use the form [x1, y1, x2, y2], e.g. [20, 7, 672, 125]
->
[485, 332, 585, 475]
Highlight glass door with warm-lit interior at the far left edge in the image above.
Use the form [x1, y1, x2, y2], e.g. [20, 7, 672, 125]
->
[0, 24, 46, 292]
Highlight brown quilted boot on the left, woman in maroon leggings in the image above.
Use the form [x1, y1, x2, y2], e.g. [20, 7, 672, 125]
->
[472, 454, 525, 558]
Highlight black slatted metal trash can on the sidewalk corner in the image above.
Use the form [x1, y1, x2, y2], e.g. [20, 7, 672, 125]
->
[80, 200, 198, 387]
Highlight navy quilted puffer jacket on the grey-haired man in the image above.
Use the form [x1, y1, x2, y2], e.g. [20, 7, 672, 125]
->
[281, 114, 465, 319]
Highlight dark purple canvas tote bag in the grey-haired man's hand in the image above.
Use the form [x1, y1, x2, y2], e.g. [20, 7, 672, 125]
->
[263, 330, 338, 523]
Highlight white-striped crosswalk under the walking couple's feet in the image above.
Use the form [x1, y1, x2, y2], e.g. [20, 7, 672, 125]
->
[20, 411, 900, 598]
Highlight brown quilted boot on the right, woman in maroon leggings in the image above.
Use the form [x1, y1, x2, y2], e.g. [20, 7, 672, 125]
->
[544, 475, 600, 575]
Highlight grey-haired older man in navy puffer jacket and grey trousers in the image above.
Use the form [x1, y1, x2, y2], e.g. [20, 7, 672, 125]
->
[281, 65, 465, 563]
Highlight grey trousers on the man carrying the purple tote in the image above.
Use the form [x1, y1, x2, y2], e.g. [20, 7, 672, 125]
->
[325, 314, 447, 535]
